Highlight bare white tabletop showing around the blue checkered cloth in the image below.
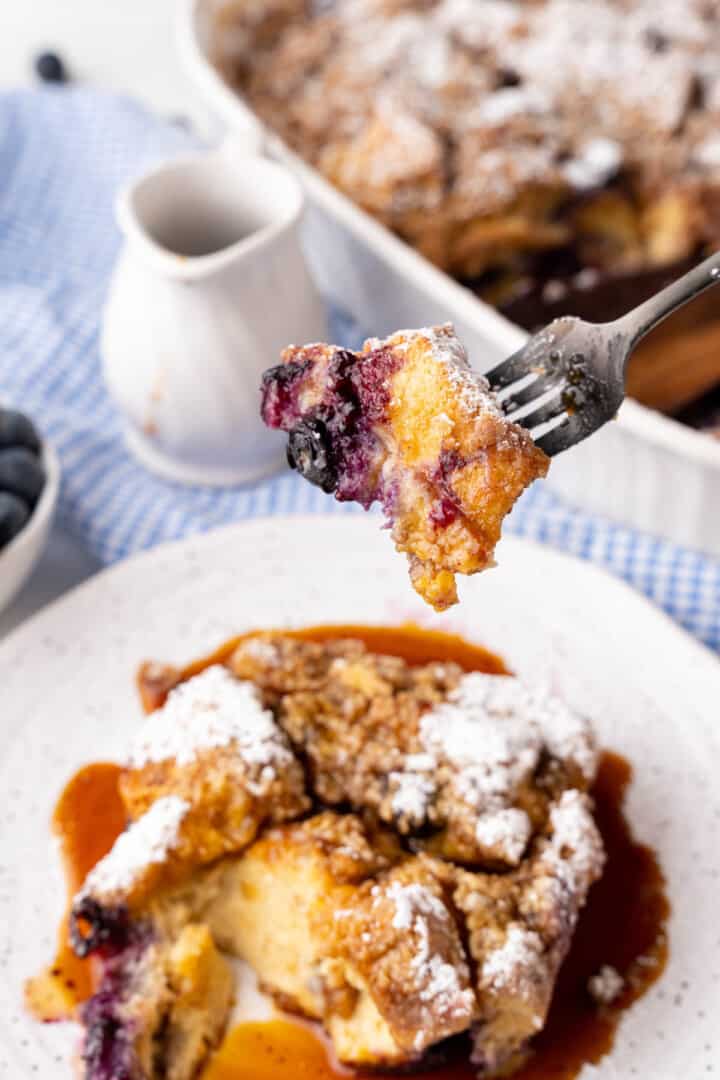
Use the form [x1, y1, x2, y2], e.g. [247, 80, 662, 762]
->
[0, 0, 208, 637]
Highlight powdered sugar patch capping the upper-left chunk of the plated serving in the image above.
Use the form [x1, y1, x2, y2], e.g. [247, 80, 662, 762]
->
[127, 664, 293, 785]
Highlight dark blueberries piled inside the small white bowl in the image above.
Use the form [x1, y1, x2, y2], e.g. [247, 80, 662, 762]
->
[0, 408, 45, 550]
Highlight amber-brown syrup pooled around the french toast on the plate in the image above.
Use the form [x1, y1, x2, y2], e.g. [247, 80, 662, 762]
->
[28, 625, 669, 1080]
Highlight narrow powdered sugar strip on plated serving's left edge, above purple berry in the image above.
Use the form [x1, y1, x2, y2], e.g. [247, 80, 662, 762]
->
[78, 795, 190, 899]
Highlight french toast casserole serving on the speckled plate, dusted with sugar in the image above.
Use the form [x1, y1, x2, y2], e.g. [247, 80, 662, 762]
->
[60, 633, 603, 1080]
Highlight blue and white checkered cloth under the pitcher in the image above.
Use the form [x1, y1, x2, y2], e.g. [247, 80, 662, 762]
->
[0, 89, 720, 649]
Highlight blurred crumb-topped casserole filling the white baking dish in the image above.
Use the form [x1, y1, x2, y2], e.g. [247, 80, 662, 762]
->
[212, 0, 720, 421]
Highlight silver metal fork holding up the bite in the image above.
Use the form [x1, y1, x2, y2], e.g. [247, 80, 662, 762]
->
[485, 253, 720, 457]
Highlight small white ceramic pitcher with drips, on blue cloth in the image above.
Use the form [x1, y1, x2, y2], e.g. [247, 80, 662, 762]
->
[103, 143, 327, 485]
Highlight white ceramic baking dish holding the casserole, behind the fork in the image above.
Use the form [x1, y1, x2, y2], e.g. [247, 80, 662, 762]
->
[179, 0, 720, 555]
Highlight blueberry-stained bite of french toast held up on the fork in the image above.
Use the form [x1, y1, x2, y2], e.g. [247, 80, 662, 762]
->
[262, 324, 548, 610]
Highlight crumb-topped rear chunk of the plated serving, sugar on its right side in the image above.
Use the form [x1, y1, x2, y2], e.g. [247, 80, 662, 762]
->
[232, 642, 597, 868]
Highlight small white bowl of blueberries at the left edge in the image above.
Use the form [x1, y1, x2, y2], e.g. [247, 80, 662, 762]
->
[0, 405, 59, 610]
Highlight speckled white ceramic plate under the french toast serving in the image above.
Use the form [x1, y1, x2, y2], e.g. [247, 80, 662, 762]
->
[0, 516, 720, 1080]
